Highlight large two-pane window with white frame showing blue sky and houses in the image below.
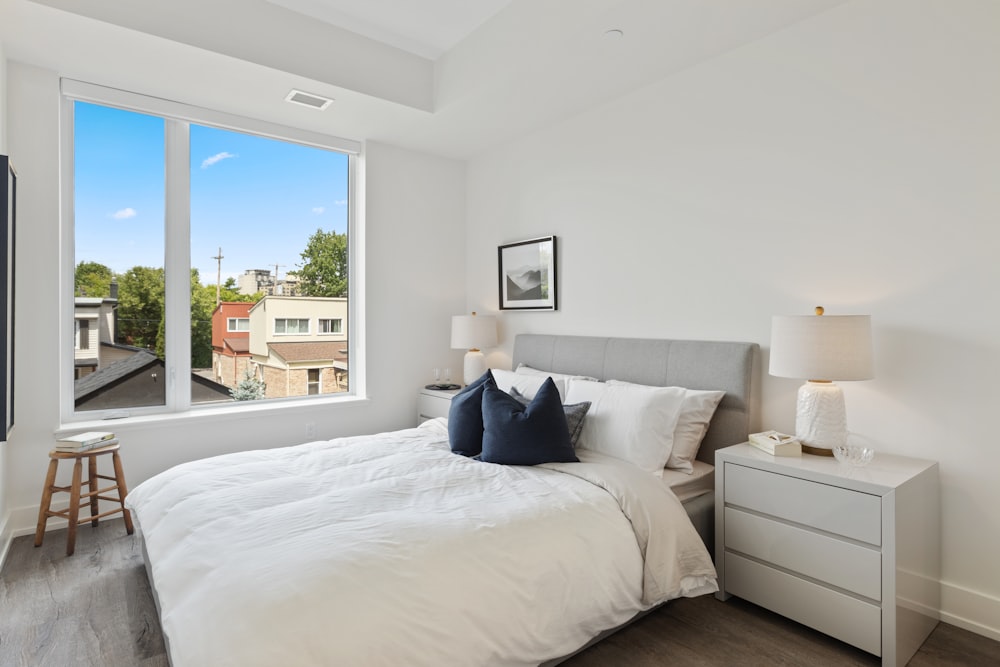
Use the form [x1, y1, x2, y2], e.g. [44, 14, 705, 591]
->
[60, 80, 360, 421]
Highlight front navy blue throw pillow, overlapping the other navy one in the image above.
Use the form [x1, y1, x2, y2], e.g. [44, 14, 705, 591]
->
[480, 378, 579, 466]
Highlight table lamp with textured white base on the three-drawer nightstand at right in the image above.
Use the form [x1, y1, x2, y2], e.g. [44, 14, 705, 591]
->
[769, 306, 874, 456]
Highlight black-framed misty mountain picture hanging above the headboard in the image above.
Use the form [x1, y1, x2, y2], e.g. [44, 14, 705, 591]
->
[497, 236, 558, 310]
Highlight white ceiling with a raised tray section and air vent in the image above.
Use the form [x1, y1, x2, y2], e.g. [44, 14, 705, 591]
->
[0, 0, 848, 159]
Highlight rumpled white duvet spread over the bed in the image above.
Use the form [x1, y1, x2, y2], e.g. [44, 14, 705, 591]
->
[126, 420, 716, 667]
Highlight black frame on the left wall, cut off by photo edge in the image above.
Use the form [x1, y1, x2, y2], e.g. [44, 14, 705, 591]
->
[0, 155, 17, 440]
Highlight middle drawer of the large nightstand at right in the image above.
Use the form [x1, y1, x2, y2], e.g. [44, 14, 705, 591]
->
[725, 507, 882, 601]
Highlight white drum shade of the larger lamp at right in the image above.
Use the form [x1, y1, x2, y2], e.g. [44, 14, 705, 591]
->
[769, 315, 874, 380]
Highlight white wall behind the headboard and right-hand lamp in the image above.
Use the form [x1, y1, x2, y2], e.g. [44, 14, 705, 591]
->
[466, 0, 1000, 639]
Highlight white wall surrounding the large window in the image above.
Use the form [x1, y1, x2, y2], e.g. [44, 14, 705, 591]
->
[5, 62, 465, 533]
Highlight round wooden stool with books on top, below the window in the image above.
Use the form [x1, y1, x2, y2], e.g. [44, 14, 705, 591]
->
[35, 443, 133, 556]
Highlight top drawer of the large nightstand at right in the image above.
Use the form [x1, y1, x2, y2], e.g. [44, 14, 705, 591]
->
[725, 462, 882, 546]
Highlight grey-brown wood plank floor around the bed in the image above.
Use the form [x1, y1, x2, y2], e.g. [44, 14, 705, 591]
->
[0, 519, 1000, 667]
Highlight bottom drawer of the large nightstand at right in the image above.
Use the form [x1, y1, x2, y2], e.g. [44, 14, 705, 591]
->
[725, 545, 882, 656]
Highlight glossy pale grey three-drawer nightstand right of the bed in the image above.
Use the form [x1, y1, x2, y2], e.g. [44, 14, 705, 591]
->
[715, 444, 941, 665]
